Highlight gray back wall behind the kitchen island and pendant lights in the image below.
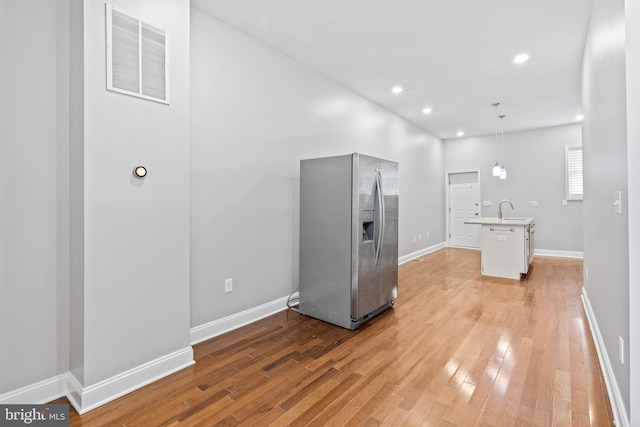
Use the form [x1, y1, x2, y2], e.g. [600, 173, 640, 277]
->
[444, 123, 583, 252]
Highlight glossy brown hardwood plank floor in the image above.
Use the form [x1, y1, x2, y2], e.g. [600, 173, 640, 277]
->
[56, 248, 613, 427]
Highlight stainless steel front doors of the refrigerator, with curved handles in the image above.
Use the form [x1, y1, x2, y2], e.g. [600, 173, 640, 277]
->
[351, 154, 398, 320]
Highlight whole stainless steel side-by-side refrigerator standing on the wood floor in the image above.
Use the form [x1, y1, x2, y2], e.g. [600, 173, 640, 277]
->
[299, 153, 398, 329]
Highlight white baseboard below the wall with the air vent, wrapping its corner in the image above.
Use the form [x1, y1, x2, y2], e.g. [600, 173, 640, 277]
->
[67, 346, 195, 414]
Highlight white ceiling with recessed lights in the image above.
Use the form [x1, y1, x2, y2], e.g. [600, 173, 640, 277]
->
[191, 0, 591, 139]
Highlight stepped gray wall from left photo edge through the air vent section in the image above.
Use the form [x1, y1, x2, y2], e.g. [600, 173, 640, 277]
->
[0, 0, 190, 394]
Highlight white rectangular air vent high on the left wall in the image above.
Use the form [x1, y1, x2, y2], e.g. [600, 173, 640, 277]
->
[106, 4, 169, 104]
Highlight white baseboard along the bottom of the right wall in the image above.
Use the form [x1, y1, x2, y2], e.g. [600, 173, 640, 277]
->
[582, 287, 629, 427]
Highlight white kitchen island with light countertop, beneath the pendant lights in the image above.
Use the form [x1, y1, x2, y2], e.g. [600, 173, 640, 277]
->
[465, 217, 535, 279]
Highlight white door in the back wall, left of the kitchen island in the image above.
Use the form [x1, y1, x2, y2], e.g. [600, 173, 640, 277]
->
[449, 174, 480, 248]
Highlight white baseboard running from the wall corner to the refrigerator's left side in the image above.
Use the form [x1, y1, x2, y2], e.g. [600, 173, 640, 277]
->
[190, 296, 289, 345]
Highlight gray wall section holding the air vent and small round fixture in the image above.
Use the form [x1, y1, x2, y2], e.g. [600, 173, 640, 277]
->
[72, 0, 189, 387]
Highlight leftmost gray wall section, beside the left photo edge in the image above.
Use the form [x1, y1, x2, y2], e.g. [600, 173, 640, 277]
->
[0, 0, 61, 394]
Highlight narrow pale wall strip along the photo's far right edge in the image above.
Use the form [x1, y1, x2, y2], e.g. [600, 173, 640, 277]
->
[625, 0, 640, 426]
